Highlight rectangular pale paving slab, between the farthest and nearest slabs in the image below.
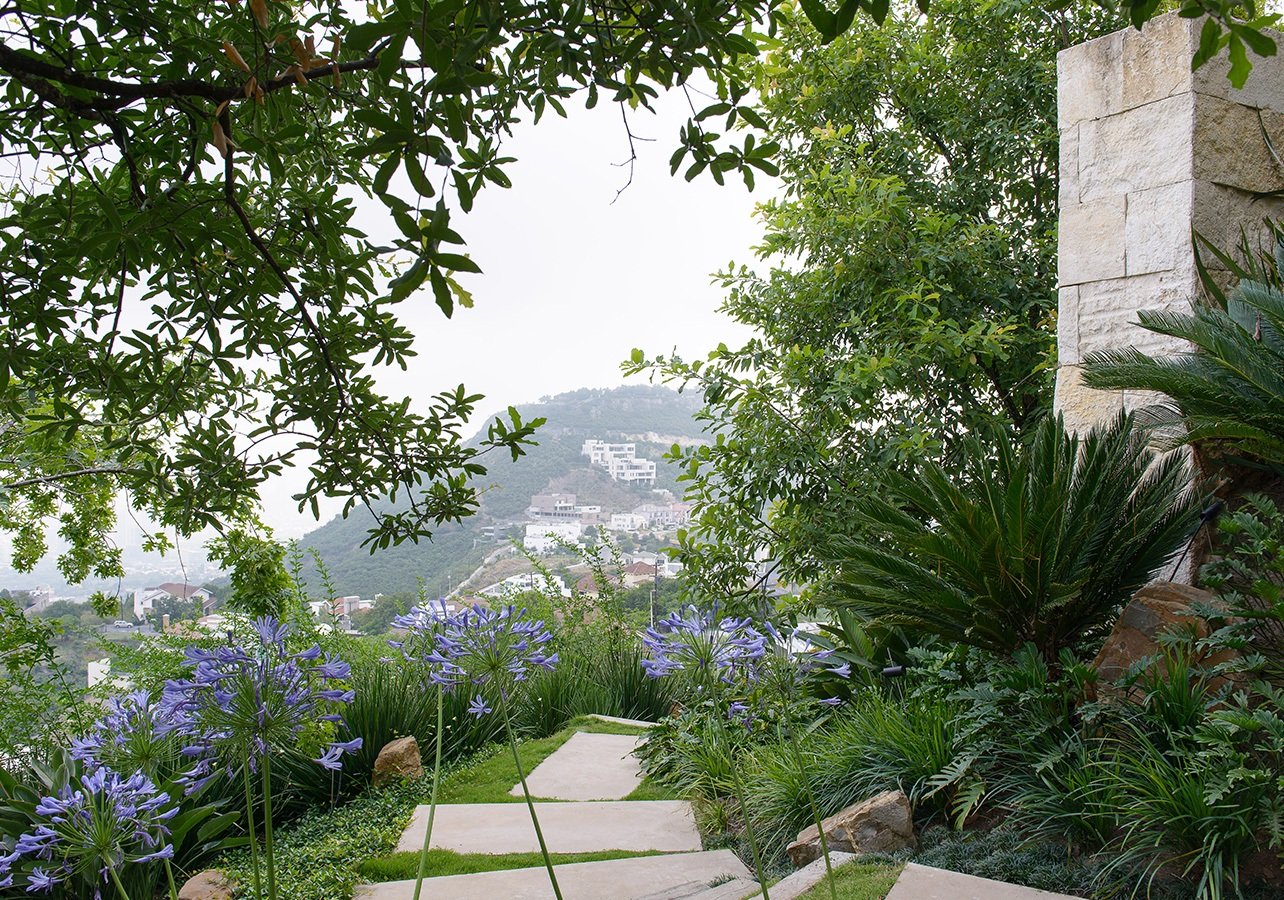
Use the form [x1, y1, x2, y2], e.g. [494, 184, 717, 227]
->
[397, 800, 701, 854]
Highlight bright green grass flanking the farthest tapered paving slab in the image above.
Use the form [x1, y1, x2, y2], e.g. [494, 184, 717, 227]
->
[437, 715, 679, 804]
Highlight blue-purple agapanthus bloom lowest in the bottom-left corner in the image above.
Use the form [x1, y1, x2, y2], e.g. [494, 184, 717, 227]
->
[0, 768, 178, 897]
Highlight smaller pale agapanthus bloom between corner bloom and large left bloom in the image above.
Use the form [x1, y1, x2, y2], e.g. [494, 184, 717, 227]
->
[71, 691, 182, 778]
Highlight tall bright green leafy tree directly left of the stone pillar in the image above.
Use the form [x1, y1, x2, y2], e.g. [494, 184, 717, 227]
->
[627, 0, 1120, 596]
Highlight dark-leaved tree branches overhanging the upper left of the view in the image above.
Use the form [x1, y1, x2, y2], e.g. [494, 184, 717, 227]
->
[0, 0, 774, 579]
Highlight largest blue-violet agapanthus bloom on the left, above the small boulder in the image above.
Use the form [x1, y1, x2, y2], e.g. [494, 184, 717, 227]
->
[162, 618, 361, 793]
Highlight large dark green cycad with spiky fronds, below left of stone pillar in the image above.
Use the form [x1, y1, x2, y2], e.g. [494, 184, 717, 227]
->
[832, 416, 1201, 664]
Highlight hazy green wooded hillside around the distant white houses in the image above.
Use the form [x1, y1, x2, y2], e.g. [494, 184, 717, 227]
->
[302, 385, 701, 597]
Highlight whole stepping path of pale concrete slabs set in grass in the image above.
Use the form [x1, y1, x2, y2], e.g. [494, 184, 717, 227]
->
[354, 716, 1088, 900]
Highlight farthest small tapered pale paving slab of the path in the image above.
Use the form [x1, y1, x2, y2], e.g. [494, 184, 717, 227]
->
[508, 732, 642, 800]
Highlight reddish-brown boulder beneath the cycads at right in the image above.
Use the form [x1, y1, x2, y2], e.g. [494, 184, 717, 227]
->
[1093, 582, 1216, 686]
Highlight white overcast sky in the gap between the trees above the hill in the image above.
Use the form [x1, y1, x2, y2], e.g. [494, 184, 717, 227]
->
[243, 87, 774, 538]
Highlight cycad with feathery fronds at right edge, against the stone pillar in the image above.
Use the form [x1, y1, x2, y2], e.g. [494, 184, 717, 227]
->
[1085, 264, 1284, 470]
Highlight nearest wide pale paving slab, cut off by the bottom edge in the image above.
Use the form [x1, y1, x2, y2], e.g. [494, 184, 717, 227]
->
[353, 847, 749, 900]
